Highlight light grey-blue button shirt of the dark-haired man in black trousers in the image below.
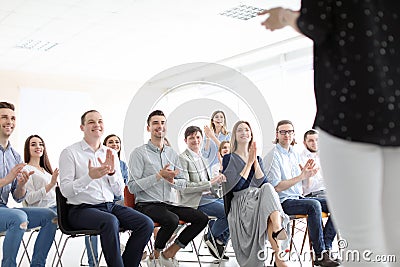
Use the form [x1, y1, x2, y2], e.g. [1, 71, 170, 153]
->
[128, 140, 186, 204]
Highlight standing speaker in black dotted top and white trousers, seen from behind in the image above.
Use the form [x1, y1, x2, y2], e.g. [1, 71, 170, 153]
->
[261, 0, 400, 266]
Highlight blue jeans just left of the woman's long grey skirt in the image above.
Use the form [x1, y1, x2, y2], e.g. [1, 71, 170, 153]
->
[197, 195, 229, 245]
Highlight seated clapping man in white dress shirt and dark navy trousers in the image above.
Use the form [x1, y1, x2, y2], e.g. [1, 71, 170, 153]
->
[59, 110, 153, 267]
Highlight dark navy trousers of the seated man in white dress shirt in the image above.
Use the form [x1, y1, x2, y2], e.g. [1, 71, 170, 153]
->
[68, 202, 154, 267]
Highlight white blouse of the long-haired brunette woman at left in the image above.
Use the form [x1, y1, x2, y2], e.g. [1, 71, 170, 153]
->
[24, 165, 56, 208]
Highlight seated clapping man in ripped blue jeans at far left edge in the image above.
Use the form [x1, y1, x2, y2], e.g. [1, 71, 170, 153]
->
[0, 102, 57, 267]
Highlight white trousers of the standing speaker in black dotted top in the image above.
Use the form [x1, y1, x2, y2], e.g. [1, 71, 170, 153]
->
[319, 131, 400, 266]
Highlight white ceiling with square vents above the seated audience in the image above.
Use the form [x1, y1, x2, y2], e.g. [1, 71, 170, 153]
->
[0, 0, 300, 81]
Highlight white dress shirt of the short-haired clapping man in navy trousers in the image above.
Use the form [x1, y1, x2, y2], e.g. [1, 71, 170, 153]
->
[59, 140, 125, 205]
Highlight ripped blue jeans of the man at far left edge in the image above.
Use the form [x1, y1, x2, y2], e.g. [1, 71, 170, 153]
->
[0, 206, 57, 267]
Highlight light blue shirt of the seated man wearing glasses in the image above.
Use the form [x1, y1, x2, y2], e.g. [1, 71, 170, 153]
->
[263, 144, 303, 203]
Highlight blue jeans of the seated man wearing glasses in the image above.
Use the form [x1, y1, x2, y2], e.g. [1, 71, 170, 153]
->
[282, 198, 336, 254]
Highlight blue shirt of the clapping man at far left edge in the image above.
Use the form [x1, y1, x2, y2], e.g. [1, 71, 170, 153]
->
[0, 142, 25, 207]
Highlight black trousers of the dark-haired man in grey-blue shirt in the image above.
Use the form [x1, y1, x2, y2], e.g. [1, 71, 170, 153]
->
[135, 202, 208, 250]
